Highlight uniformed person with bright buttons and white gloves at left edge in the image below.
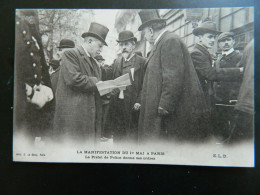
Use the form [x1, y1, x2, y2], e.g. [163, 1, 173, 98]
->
[14, 10, 53, 143]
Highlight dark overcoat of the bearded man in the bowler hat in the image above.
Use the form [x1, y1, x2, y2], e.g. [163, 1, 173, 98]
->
[109, 54, 146, 140]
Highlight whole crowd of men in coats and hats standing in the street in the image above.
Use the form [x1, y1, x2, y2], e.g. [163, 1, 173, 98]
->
[14, 10, 254, 144]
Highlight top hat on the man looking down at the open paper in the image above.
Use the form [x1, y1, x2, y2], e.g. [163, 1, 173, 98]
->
[81, 22, 109, 46]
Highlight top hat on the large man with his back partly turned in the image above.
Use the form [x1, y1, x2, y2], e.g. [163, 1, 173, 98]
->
[138, 10, 166, 31]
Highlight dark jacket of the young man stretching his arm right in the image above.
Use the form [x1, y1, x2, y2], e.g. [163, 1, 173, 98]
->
[191, 44, 243, 109]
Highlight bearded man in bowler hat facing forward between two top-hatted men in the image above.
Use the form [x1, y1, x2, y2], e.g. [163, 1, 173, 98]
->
[109, 30, 145, 142]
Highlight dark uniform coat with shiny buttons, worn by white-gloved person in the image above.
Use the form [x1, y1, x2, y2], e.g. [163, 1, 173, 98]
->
[14, 17, 53, 137]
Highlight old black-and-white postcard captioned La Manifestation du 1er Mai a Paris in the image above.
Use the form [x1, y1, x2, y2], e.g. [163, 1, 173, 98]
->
[13, 7, 255, 167]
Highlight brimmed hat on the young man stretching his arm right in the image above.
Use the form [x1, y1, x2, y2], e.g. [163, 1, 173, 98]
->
[192, 21, 220, 36]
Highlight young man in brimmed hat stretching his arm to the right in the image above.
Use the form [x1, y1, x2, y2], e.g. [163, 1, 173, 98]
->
[191, 21, 241, 139]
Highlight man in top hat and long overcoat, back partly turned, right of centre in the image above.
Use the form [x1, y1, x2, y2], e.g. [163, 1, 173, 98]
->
[138, 10, 208, 142]
